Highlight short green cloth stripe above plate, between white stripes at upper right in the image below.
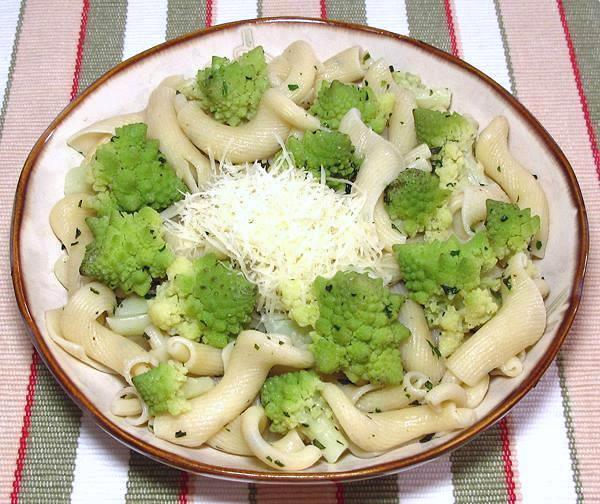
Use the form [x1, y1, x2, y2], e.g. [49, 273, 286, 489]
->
[406, 0, 451, 52]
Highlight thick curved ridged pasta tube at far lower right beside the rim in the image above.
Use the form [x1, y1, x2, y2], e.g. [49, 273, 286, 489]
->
[446, 253, 546, 386]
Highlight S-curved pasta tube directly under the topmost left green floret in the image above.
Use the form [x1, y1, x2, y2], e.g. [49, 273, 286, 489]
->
[177, 89, 320, 163]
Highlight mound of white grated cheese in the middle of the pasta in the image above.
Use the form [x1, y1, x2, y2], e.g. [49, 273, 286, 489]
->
[164, 163, 391, 313]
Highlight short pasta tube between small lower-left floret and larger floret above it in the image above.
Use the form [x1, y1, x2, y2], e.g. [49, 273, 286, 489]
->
[167, 336, 223, 376]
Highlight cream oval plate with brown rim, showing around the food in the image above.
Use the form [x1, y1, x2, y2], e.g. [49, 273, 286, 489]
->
[11, 18, 588, 483]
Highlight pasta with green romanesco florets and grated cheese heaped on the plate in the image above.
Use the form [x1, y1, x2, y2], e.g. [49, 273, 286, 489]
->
[46, 41, 549, 471]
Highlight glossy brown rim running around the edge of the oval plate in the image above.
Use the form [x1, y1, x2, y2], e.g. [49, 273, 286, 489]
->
[10, 17, 589, 483]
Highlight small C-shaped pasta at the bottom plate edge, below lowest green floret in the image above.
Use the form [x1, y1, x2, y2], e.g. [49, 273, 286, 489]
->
[242, 406, 321, 471]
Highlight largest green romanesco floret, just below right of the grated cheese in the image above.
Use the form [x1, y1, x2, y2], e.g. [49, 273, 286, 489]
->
[311, 271, 409, 384]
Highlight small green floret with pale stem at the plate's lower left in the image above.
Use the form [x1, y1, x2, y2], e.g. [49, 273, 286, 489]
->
[132, 362, 190, 415]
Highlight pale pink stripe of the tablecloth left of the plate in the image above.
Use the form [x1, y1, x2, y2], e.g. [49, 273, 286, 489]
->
[0, 0, 81, 502]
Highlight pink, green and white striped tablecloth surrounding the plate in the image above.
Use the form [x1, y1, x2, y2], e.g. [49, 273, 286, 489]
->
[0, 0, 600, 503]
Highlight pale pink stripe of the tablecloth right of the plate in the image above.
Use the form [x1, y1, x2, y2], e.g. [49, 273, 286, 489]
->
[501, 0, 600, 501]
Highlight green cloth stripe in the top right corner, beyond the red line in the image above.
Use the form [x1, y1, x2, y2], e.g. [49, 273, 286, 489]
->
[563, 0, 600, 139]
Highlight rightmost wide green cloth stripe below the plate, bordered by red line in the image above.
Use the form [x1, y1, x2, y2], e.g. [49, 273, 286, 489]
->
[450, 425, 508, 504]
